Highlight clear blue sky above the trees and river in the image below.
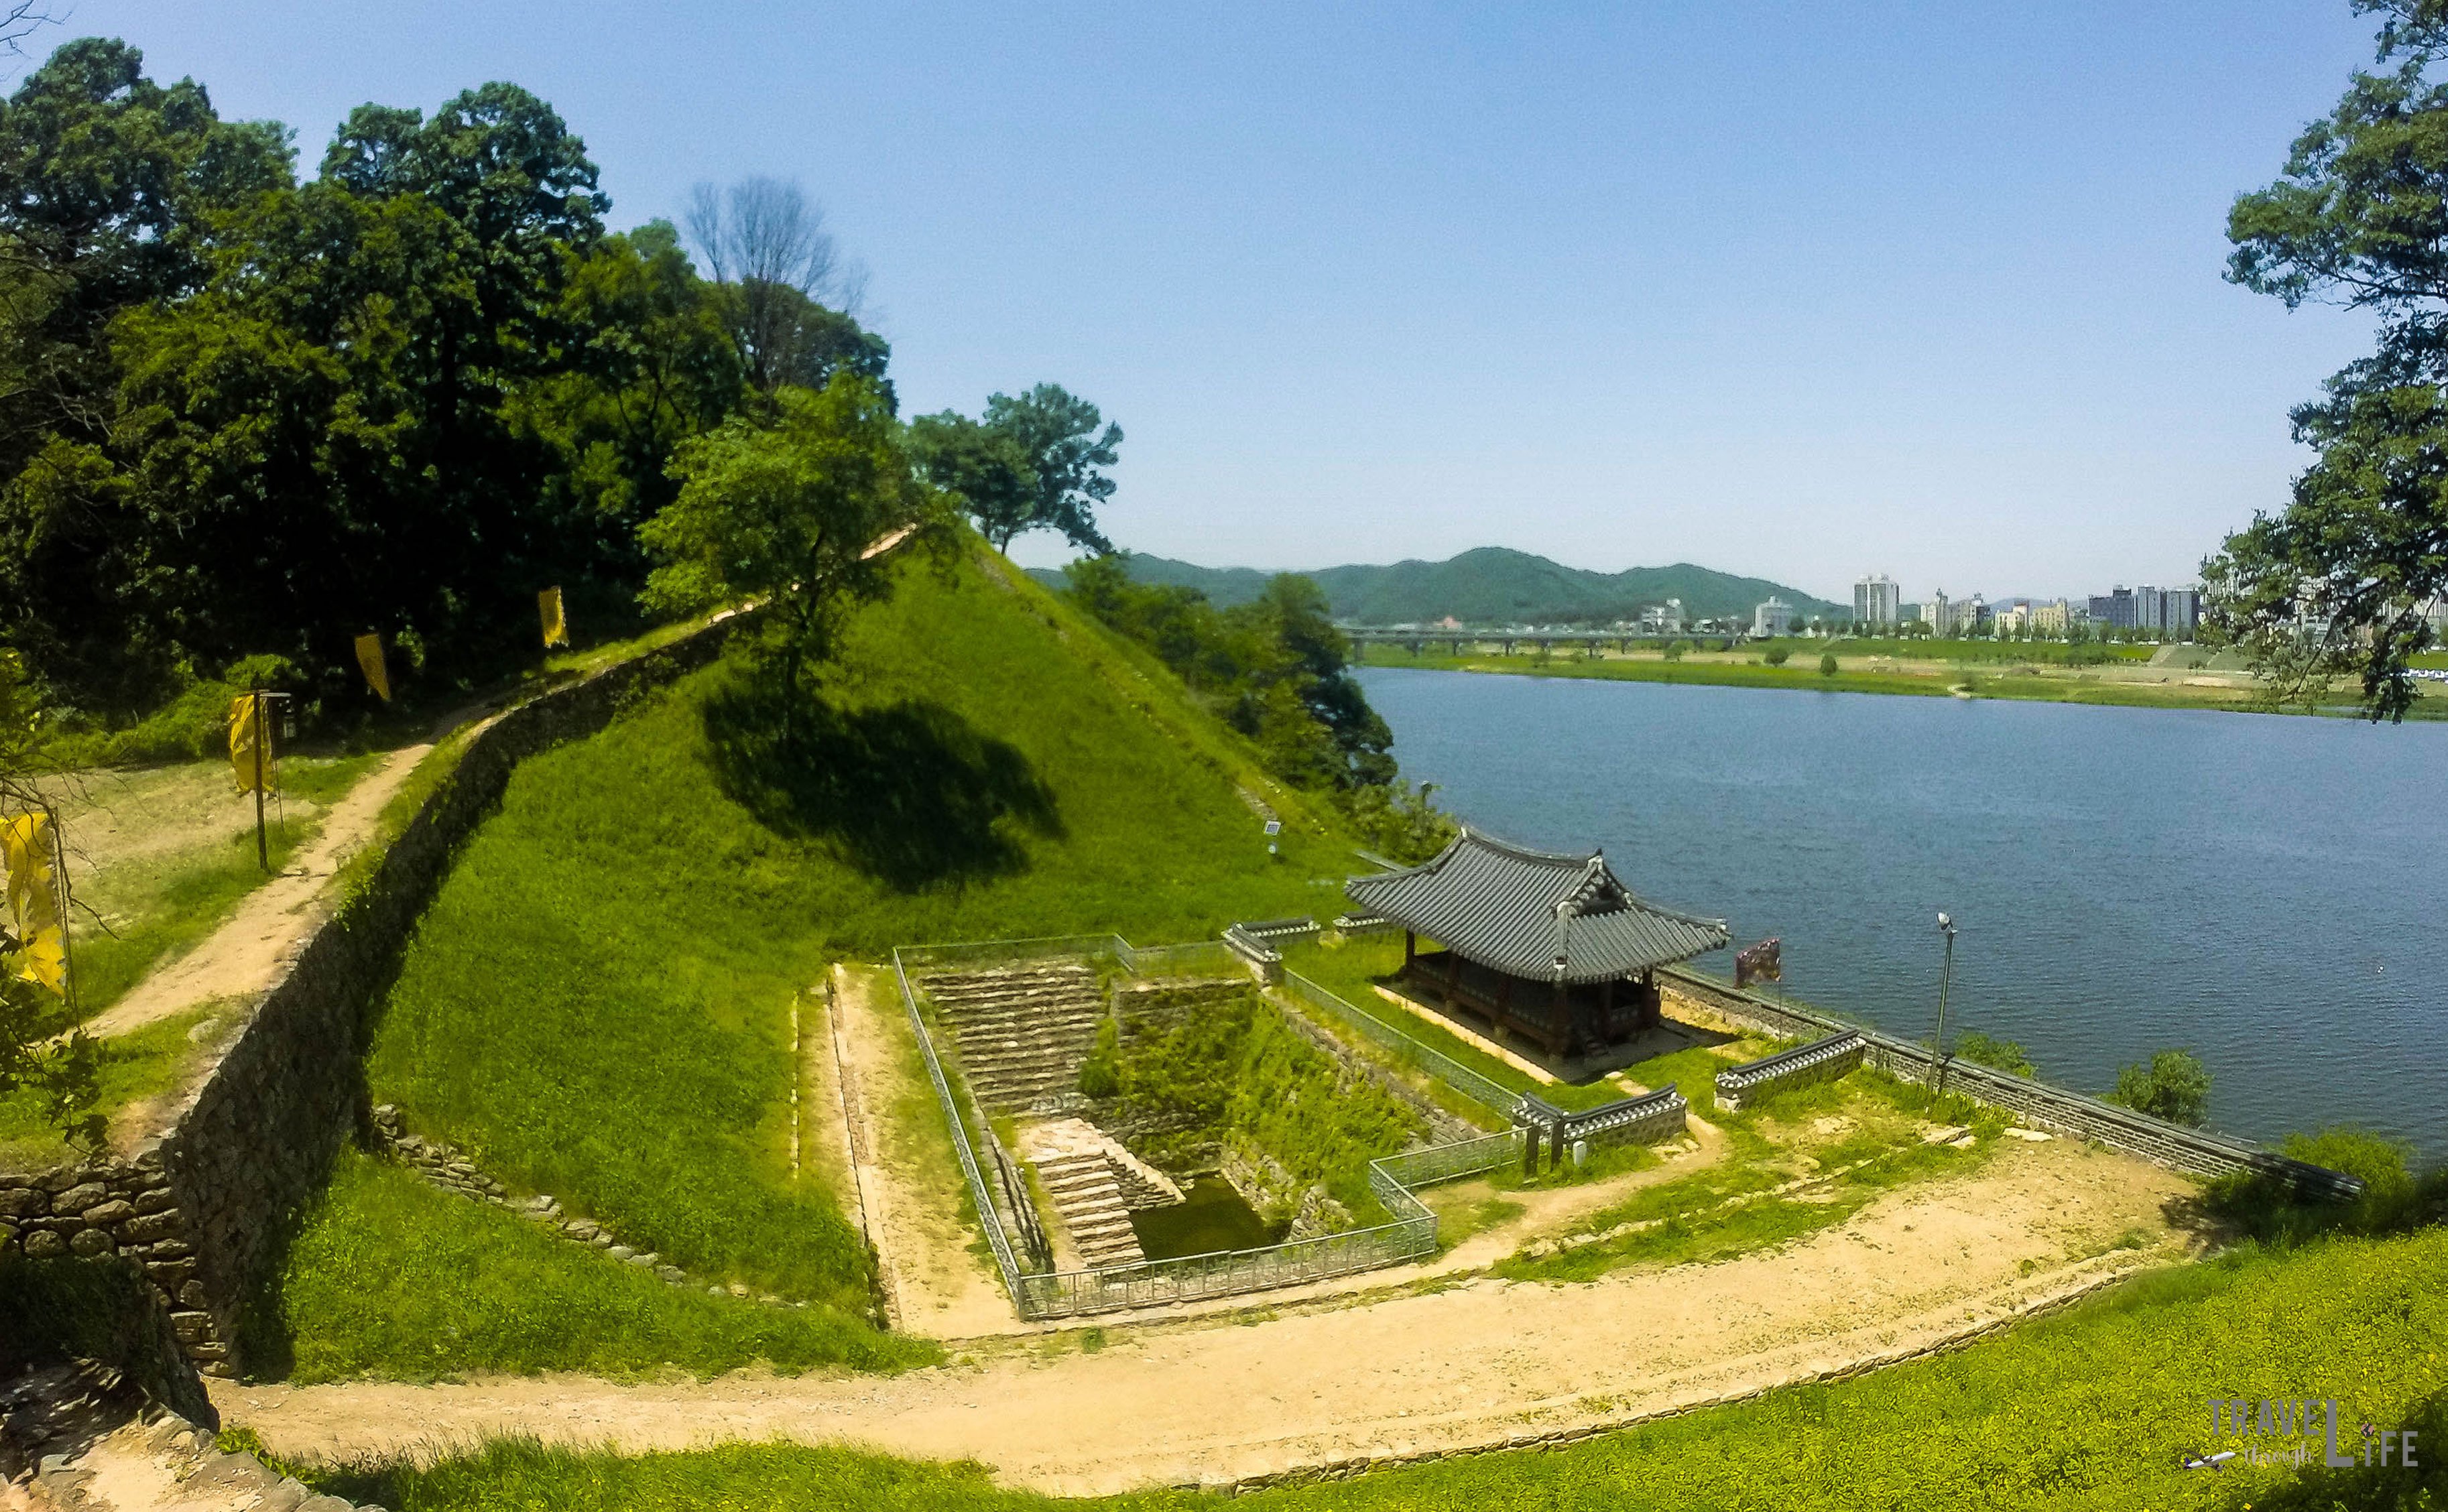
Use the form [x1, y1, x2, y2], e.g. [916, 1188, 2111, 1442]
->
[19, 0, 2370, 599]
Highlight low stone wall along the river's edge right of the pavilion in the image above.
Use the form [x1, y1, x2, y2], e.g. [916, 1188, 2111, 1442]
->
[1657, 966, 2362, 1201]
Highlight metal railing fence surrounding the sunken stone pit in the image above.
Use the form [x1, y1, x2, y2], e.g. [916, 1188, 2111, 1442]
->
[894, 934, 1523, 1319]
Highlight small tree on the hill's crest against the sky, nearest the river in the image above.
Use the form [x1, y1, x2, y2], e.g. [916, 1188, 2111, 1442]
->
[925, 384, 1121, 553]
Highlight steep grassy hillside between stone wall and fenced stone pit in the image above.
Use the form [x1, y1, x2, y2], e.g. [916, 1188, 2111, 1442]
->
[262, 540, 1361, 1377]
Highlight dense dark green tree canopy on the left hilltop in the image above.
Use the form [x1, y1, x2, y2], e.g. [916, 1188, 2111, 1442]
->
[0, 39, 915, 722]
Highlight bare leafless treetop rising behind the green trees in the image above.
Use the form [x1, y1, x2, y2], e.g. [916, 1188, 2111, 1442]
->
[686, 178, 891, 394]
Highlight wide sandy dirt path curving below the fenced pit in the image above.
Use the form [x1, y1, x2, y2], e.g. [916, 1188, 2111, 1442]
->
[213, 1143, 2191, 1495]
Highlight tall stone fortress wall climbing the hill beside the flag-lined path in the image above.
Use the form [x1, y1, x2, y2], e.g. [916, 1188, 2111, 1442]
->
[0, 604, 751, 1375]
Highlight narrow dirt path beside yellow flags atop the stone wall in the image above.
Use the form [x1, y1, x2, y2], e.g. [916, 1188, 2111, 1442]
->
[86, 744, 433, 1037]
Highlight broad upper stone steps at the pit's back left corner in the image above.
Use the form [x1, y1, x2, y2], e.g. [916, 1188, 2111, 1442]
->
[923, 962, 1104, 1113]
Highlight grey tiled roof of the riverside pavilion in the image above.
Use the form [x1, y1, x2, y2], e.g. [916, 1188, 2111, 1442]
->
[1344, 830, 1728, 981]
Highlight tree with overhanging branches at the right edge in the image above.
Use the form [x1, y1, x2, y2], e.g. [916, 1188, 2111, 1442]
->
[2203, 0, 2448, 722]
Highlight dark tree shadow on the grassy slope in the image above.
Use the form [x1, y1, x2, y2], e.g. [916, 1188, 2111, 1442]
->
[705, 676, 1062, 893]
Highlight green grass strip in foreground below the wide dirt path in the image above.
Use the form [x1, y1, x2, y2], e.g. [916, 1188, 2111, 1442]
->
[267, 1228, 2448, 1512]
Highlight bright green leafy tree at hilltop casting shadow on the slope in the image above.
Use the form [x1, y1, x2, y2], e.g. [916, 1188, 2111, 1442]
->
[639, 372, 942, 714]
